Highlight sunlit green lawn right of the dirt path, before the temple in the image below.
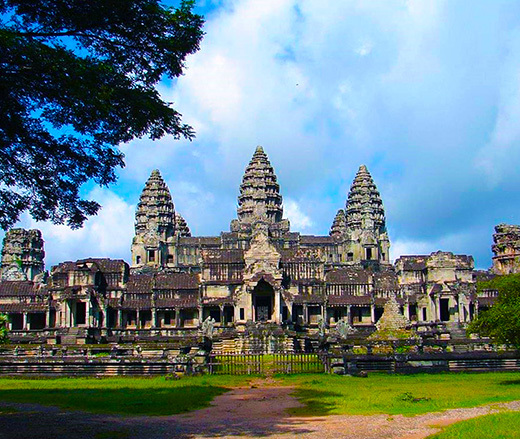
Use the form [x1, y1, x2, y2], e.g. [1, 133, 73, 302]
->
[282, 373, 520, 416]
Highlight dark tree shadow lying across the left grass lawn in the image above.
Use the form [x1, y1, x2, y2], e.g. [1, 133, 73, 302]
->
[0, 386, 228, 416]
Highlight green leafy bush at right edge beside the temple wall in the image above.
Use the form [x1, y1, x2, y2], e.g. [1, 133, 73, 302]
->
[468, 274, 520, 348]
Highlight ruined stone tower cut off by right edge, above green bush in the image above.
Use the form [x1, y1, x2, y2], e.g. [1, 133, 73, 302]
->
[491, 224, 520, 274]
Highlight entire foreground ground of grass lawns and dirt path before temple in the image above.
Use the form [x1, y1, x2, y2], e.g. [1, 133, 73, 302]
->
[0, 373, 520, 439]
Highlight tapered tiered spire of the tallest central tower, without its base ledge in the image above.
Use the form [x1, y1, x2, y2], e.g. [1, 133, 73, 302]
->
[237, 146, 283, 223]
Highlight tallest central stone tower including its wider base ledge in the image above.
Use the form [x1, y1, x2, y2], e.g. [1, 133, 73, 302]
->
[231, 146, 289, 236]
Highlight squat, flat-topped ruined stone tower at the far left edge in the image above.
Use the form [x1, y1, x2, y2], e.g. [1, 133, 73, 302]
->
[0, 229, 45, 281]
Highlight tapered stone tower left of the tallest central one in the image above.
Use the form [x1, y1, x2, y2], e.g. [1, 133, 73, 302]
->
[132, 169, 175, 268]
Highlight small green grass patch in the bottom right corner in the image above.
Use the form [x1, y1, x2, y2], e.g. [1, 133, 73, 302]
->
[429, 412, 520, 439]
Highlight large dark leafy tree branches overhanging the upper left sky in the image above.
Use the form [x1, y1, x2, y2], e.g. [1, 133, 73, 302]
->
[0, 0, 203, 229]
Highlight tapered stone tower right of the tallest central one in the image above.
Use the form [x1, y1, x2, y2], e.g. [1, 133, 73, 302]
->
[345, 165, 390, 264]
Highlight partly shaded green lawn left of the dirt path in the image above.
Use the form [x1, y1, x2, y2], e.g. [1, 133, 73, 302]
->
[0, 376, 246, 416]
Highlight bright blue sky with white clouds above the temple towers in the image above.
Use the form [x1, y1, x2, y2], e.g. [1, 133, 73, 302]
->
[9, 0, 520, 268]
